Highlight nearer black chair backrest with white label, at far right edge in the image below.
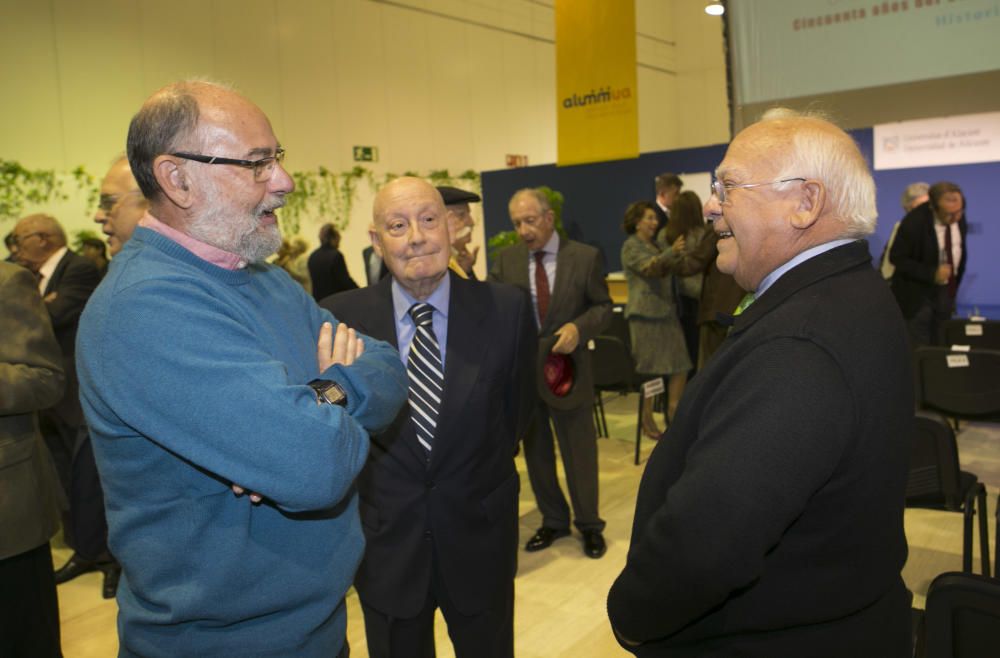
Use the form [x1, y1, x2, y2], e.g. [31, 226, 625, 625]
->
[916, 347, 1000, 419]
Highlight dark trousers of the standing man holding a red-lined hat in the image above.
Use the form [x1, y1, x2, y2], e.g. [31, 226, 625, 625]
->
[524, 403, 604, 530]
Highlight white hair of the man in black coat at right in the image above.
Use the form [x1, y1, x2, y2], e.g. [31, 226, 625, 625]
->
[760, 107, 878, 238]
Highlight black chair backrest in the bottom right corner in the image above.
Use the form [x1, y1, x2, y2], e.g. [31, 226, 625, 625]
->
[924, 572, 1000, 658]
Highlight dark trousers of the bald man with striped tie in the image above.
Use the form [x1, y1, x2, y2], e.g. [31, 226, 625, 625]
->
[361, 565, 514, 658]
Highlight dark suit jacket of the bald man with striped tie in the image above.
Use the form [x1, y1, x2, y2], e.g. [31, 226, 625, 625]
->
[321, 272, 535, 618]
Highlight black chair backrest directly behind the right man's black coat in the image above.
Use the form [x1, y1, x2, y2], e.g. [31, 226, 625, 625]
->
[906, 411, 963, 510]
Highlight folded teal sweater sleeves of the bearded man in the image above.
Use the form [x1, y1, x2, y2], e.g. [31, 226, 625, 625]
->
[90, 282, 399, 511]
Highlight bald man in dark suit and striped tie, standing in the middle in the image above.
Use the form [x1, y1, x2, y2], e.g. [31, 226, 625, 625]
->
[321, 177, 535, 658]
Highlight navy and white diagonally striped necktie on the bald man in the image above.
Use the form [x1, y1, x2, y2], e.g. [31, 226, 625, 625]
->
[406, 304, 444, 452]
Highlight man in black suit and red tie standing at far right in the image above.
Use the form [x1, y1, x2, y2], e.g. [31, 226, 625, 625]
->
[889, 182, 968, 345]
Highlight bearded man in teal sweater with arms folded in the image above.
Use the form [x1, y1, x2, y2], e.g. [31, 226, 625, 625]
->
[77, 82, 406, 658]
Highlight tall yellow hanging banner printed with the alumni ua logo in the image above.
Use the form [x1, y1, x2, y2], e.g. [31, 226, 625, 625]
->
[556, 0, 639, 165]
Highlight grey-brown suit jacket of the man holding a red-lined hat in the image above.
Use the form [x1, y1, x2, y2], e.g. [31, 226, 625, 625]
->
[490, 239, 611, 410]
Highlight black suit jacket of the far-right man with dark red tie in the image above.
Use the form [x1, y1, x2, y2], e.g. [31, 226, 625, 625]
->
[889, 202, 969, 318]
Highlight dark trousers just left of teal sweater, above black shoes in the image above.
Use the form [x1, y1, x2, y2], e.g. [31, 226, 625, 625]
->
[66, 426, 109, 562]
